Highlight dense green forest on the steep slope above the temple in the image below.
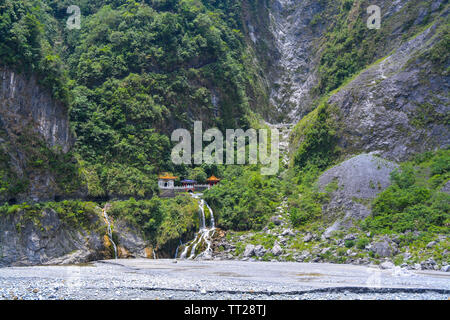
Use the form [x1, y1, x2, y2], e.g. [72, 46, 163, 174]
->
[67, 0, 266, 197]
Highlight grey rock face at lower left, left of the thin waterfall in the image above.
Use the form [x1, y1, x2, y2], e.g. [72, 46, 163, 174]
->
[0, 209, 105, 266]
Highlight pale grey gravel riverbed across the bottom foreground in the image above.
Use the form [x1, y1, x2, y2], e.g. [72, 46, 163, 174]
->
[0, 259, 450, 300]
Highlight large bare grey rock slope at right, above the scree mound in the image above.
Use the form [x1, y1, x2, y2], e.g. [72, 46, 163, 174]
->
[328, 25, 450, 161]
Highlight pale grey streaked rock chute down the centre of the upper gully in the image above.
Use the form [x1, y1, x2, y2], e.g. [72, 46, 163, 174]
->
[269, 0, 325, 121]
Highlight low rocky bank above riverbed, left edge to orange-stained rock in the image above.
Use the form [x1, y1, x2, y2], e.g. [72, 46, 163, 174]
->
[0, 207, 153, 266]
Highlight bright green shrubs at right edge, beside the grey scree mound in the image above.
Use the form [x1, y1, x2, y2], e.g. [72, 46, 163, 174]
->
[362, 149, 450, 234]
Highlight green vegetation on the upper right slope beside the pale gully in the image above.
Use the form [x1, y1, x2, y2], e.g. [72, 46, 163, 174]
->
[313, 0, 442, 95]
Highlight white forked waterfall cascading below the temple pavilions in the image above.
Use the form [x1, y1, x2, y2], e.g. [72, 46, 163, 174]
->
[175, 194, 215, 259]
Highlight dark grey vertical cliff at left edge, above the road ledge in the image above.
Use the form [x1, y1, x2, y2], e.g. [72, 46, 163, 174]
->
[0, 67, 75, 201]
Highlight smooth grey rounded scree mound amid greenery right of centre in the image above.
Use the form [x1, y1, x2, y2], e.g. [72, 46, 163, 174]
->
[318, 154, 398, 237]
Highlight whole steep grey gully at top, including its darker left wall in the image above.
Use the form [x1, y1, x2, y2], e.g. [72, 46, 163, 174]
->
[244, 0, 324, 123]
